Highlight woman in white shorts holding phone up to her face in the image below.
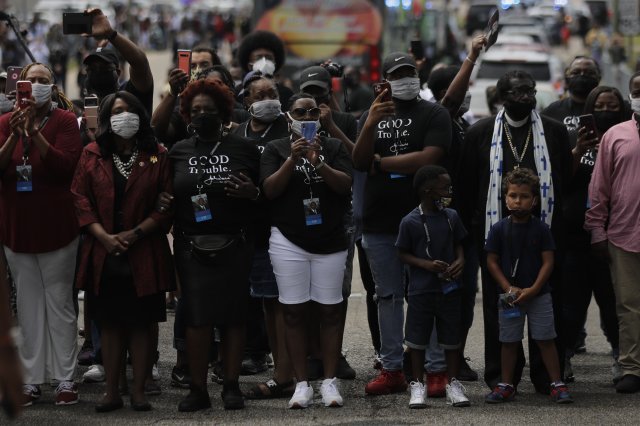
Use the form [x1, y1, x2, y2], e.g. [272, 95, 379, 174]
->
[260, 94, 352, 408]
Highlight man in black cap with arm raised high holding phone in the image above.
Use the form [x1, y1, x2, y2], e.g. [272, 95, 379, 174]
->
[83, 9, 153, 116]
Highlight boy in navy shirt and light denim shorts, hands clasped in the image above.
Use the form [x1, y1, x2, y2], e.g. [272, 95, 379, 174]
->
[485, 168, 573, 404]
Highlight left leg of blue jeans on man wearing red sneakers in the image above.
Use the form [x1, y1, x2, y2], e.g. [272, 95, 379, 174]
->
[362, 233, 405, 371]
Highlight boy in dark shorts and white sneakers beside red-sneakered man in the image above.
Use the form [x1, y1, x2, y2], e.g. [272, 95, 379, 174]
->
[396, 166, 470, 408]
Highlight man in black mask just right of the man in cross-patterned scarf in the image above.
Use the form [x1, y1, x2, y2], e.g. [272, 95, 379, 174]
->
[542, 56, 601, 135]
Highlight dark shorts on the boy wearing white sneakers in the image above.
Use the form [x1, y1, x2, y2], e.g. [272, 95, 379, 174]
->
[404, 289, 462, 350]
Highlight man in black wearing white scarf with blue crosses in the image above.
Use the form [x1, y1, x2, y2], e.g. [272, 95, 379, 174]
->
[456, 70, 571, 393]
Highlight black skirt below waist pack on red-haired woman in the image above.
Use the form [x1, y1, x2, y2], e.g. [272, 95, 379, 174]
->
[173, 236, 253, 327]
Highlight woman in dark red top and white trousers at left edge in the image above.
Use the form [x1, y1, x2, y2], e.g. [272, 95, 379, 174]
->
[0, 63, 82, 405]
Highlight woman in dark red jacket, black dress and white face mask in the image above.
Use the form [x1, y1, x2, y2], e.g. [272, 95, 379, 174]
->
[71, 92, 175, 412]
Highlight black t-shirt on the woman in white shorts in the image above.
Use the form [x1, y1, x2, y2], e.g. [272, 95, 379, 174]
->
[260, 137, 352, 254]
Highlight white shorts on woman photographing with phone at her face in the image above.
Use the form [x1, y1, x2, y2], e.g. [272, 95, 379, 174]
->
[269, 227, 347, 305]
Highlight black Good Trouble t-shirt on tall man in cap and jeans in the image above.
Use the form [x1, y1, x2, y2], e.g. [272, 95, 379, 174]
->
[360, 99, 451, 235]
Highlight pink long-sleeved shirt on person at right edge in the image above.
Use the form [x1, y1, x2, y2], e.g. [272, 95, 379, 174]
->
[584, 115, 640, 253]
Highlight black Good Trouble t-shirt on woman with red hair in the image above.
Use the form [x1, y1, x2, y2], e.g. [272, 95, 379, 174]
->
[169, 134, 260, 235]
